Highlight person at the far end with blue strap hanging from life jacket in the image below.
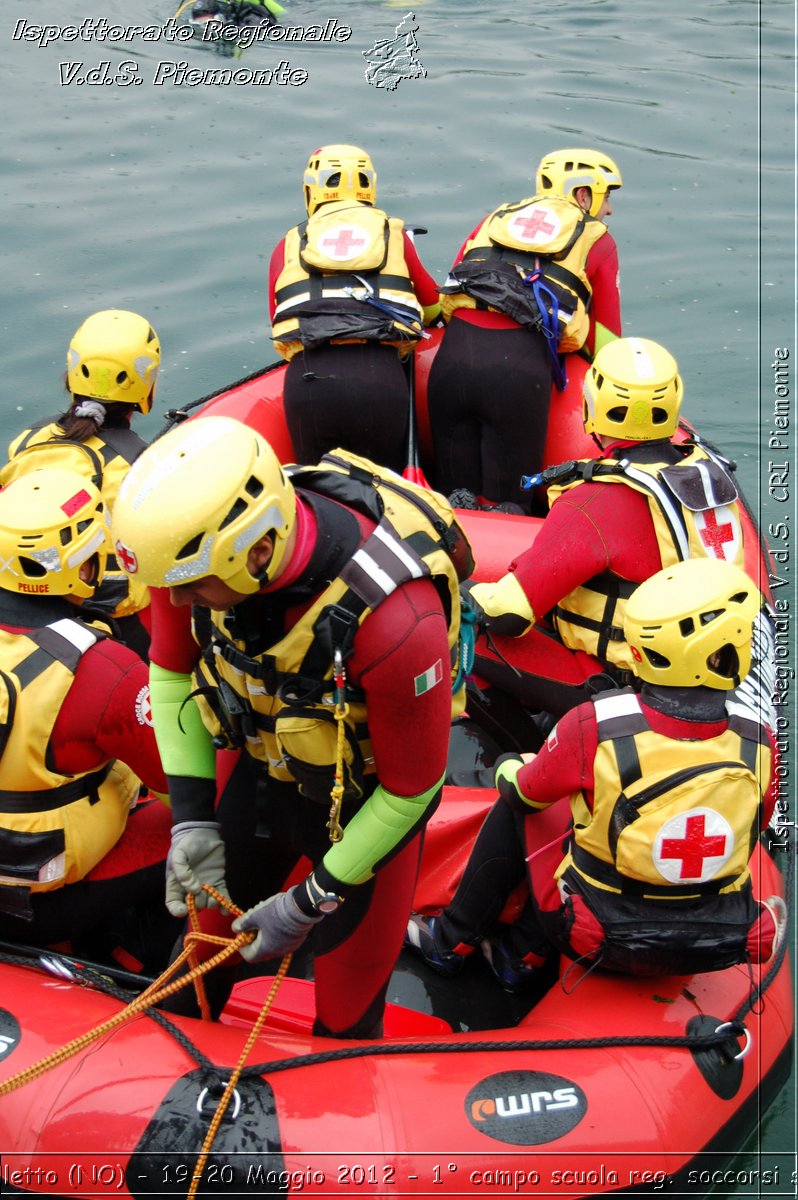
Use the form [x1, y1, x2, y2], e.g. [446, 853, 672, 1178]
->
[428, 149, 622, 511]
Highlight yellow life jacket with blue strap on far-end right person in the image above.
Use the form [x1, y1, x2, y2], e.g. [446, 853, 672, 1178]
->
[440, 196, 607, 354]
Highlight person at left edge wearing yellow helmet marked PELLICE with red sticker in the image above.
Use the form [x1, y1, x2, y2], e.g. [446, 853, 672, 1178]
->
[0, 467, 176, 970]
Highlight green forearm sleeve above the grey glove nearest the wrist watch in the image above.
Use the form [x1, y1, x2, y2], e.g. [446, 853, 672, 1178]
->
[316, 776, 443, 886]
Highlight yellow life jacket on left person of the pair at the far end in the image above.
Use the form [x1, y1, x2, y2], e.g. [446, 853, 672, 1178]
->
[271, 200, 424, 361]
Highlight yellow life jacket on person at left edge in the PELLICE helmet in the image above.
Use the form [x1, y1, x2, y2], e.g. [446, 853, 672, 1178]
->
[0, 617, 139, 908]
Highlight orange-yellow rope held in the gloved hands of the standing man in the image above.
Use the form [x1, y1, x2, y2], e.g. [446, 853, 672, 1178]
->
[0, 884, 292, 1198]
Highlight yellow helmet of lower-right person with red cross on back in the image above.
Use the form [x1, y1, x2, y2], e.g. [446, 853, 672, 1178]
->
[624, 558, 762, 691]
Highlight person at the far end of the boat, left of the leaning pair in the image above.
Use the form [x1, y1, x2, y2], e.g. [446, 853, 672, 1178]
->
[269, 145, 440, 472]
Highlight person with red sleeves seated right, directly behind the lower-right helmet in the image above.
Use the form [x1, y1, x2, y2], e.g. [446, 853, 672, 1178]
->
[460, 337, 774, 724]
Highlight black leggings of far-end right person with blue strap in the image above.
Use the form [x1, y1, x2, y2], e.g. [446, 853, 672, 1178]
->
[427, 317, 551, 511]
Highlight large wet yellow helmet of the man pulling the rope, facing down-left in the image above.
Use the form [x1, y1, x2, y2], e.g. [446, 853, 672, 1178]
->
[112, 416, 296, 595]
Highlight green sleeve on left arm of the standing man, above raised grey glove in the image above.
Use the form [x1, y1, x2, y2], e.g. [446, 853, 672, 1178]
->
[150, 662, 216, 779]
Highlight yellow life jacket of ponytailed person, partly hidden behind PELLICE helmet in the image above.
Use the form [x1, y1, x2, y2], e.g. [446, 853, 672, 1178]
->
[0, 421, 150, 617]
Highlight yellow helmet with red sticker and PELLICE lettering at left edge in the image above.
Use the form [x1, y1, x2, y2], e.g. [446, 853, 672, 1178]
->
[0, 467, 108, 600]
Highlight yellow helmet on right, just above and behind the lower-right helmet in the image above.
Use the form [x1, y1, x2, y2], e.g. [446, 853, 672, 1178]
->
[582, 337, 683, 442]
